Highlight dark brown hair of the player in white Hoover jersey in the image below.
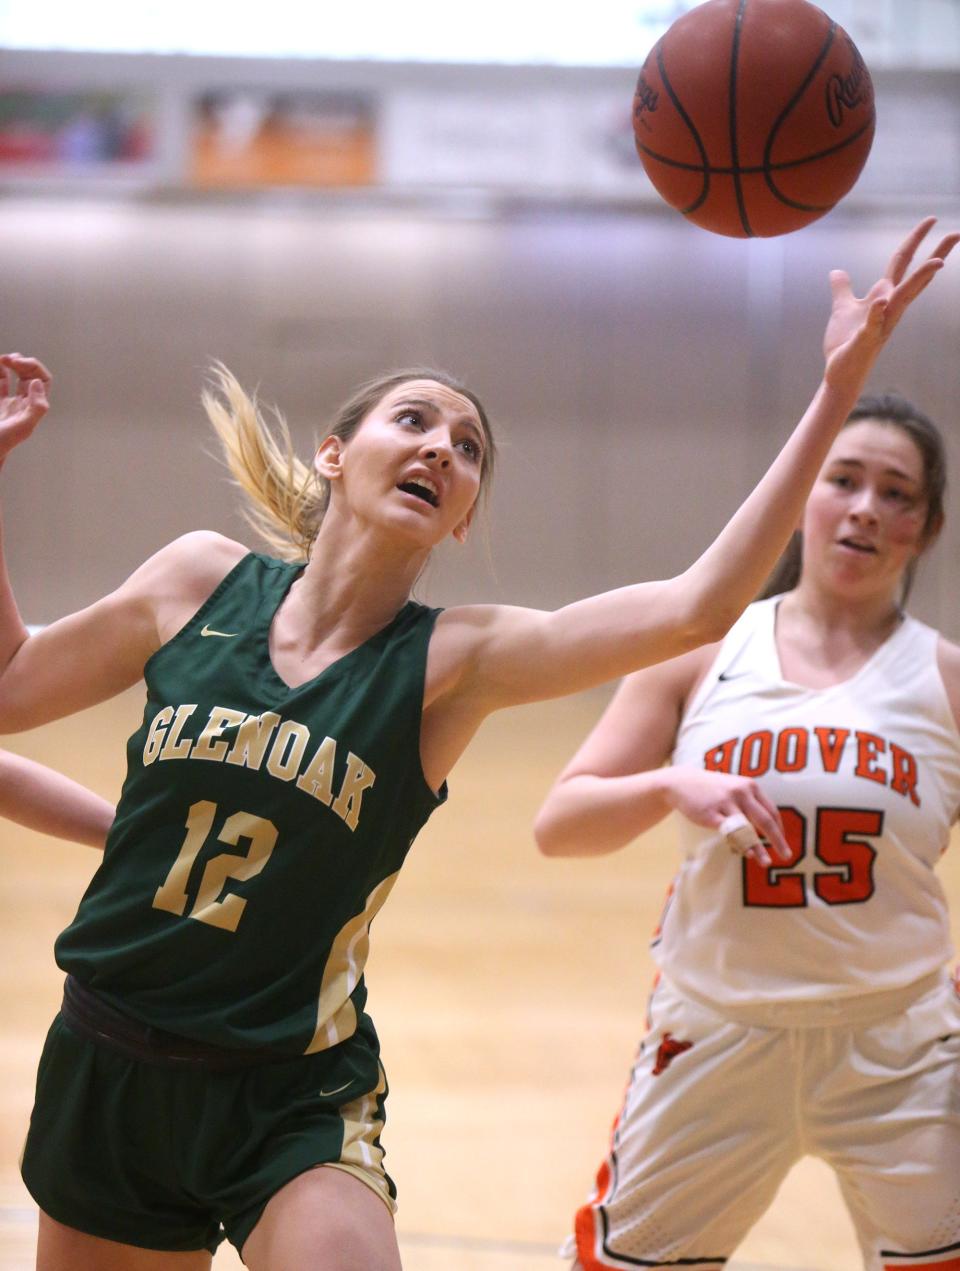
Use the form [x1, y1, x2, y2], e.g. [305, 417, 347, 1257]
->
[760, 393, 947, 605]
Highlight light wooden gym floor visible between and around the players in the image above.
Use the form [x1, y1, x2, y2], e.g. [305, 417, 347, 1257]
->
[0, 693, 960, 1271]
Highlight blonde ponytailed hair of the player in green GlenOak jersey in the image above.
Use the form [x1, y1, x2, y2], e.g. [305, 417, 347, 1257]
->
[201, 362, 496, 561]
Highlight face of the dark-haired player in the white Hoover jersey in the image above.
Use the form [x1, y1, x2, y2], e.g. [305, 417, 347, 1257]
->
[804, 419, 927, 595]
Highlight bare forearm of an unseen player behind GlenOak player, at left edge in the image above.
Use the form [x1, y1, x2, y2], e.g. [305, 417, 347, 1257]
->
[0, 750, 114, 848]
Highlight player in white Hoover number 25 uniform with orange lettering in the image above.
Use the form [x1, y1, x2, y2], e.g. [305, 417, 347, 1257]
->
[537, 395, 960, 1271]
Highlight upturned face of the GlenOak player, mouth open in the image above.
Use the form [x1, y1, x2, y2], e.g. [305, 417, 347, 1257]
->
[317, 380, 486, 548]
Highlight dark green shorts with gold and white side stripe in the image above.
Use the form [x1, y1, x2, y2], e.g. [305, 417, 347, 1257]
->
[20, 1016, 397, 1252]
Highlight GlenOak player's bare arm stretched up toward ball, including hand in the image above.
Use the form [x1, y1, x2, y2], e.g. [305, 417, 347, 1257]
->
[435, 219, 960, 717]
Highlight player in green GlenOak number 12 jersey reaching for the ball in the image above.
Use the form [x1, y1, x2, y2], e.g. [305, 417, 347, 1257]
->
[0, 220, 960, 1271]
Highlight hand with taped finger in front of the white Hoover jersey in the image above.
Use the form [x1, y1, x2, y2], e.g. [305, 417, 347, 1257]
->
[664, 765, 791, 866]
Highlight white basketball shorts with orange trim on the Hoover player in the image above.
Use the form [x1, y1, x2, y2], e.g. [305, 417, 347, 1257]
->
[575, 974, 960, 1271]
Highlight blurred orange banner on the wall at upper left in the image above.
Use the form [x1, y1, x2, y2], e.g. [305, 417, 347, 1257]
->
[191, 88, 379, 189]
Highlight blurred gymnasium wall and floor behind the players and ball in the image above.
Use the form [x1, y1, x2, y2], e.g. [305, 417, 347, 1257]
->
[0, 0, 960, 1271]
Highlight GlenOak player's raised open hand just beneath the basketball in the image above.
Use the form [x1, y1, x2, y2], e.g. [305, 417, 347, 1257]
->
[824, 216, 960, 391]
